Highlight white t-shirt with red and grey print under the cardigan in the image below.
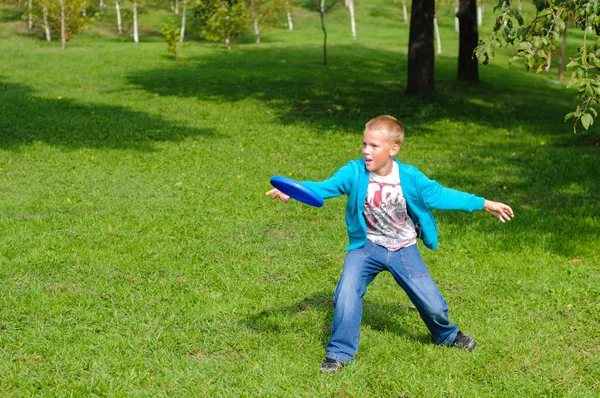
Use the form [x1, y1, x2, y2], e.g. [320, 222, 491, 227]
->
[363, 162, 417, 250]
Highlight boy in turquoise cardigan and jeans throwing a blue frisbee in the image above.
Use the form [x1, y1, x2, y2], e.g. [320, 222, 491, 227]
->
[266, 115, 514, 372]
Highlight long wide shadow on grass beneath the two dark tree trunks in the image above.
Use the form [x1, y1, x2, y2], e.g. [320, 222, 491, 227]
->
[129, 45, 584, 134]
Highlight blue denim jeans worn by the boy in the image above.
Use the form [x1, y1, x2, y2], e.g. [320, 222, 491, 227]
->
[326, 241, 458, 362]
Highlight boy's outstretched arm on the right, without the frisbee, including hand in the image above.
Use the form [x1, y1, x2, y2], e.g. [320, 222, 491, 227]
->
[418, 173, 514, 223]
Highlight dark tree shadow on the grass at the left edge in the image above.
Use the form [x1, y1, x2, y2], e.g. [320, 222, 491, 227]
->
[0, 81, 214, 151]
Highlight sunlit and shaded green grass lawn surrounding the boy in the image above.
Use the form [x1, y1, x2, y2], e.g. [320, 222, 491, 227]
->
[0, 0, 600, 397]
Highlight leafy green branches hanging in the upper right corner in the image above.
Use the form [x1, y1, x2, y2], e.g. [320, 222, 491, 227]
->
[475, 0, 600, 132]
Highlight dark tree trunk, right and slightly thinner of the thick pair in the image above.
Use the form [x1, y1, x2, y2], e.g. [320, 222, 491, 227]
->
[456, 0, 479, 82]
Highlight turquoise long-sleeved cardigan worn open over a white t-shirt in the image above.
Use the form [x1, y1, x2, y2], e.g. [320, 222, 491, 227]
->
[302, 158, 484, 251]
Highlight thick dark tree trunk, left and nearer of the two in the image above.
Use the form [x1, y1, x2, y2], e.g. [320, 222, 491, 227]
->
[406, 0, 435, 94]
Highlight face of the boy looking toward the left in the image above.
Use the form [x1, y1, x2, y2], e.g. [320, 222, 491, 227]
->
[362, 130, 400, 176]
